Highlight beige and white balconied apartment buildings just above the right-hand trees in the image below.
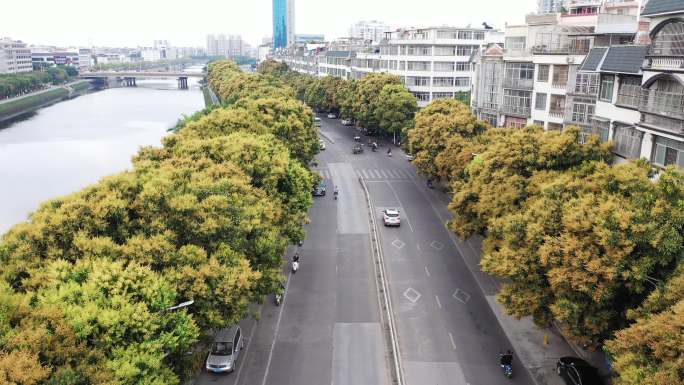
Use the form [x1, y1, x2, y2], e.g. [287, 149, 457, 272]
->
[471, 0, 638, 132]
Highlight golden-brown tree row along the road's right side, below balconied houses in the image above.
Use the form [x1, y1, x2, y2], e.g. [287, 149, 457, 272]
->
[408, 100, 684, 385]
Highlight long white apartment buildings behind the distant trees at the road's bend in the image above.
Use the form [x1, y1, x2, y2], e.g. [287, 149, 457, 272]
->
[278, 27, 503, 107]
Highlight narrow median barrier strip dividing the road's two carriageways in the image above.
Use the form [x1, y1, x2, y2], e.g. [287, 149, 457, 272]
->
[359, 178, 404, 385]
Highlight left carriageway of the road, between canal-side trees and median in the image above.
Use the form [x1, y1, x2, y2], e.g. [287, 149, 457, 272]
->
[197, 115, 390, 385]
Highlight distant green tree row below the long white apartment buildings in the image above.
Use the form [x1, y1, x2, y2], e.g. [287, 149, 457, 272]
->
[259, 61, 417, 141]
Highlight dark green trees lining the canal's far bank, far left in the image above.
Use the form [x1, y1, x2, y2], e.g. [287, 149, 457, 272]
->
[0, 66, 73, 99]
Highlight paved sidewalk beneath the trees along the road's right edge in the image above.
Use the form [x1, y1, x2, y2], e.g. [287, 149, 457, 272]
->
[422, 184, 610, 385]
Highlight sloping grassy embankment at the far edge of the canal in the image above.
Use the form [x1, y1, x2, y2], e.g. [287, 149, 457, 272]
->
[0, 80, 92, 122]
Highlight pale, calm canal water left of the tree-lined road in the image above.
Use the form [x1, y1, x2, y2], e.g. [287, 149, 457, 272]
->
[0, 70, 204, 234]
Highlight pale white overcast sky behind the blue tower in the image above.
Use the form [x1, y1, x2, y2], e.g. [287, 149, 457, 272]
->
[0, 0, 536, 47]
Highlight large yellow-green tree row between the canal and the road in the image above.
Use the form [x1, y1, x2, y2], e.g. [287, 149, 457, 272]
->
[0, 62, 318, 385]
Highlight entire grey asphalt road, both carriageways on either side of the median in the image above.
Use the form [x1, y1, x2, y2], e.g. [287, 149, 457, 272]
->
[198, 117, 532, 385]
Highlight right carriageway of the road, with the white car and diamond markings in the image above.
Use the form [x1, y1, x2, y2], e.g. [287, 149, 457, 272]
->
[323, 115, 532, 385]
